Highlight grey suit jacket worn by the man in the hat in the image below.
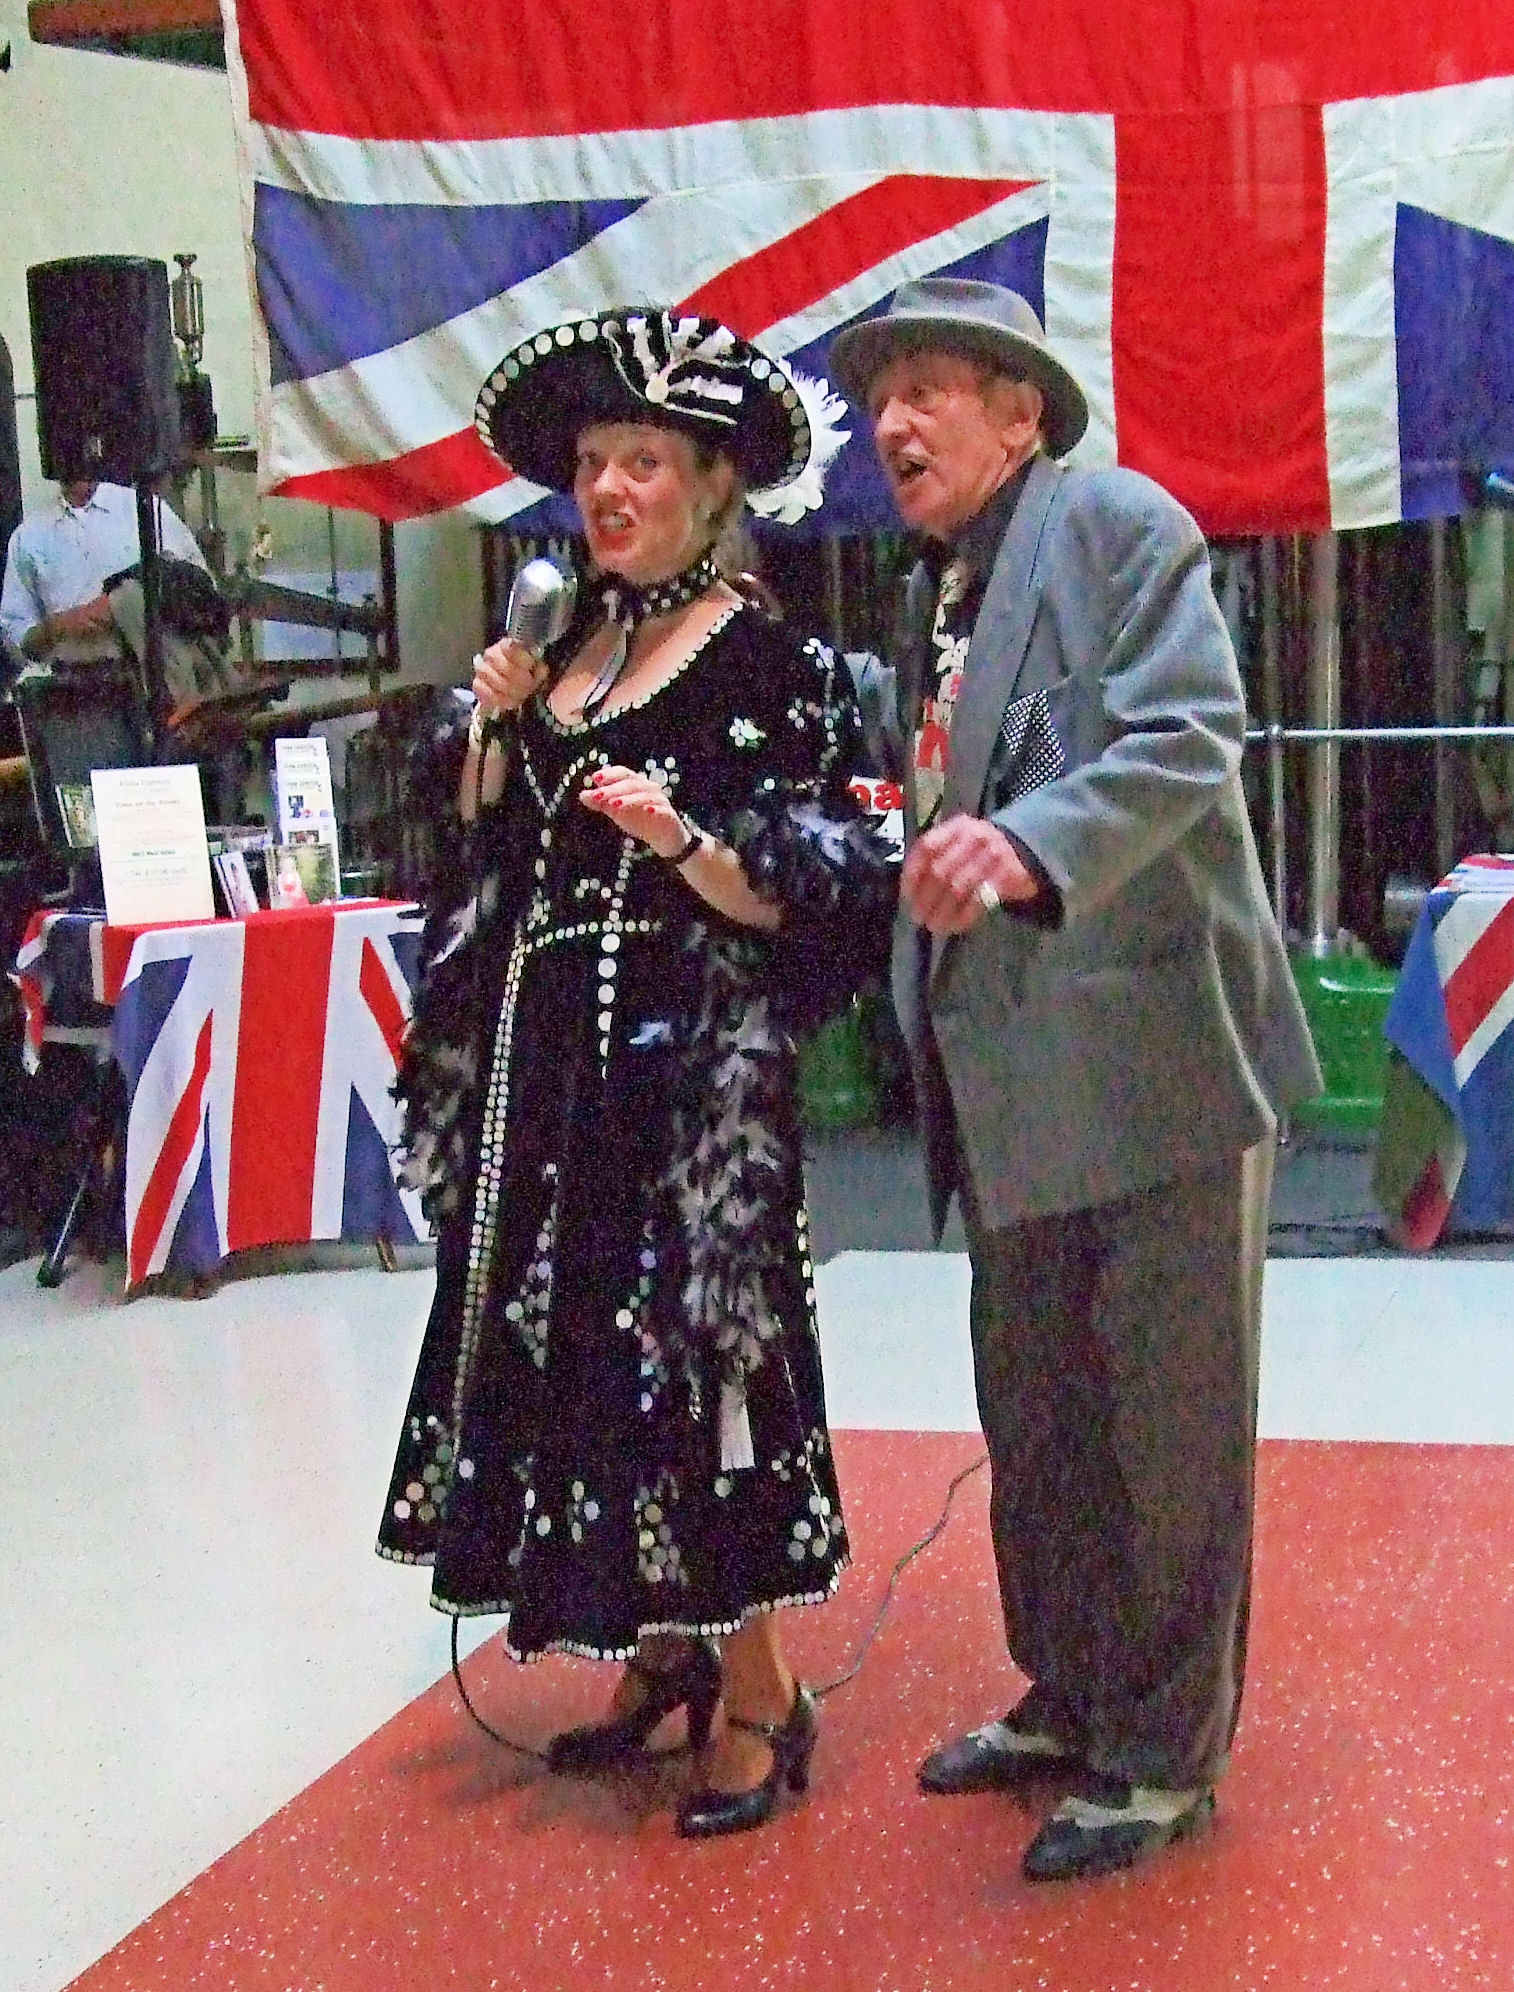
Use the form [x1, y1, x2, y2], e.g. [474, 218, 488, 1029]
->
[859, 458, 1321, 1233]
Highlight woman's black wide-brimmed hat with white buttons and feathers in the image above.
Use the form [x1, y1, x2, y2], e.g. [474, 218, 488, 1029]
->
[474, 305, 849, 524]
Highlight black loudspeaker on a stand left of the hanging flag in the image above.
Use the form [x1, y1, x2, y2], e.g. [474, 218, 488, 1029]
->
[26, 255, 181, 484]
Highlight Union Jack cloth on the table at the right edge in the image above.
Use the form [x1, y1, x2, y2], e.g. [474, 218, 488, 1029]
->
[1373, 857, 1514, 1251]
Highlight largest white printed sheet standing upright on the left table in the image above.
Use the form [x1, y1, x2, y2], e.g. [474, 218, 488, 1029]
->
[90, 765, 215, 926]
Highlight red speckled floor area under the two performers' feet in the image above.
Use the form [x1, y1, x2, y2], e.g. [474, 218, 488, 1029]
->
[65, 1432, 1514, 1992]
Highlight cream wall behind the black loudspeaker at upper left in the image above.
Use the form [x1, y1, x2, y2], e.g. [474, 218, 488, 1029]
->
[0, 0, 480, 681]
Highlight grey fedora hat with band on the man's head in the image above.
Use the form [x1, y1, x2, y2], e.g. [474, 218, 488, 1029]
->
[831, 277, 1088, 456]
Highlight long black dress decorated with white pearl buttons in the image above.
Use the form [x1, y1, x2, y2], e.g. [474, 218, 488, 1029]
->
[379, 606, 892, 1659]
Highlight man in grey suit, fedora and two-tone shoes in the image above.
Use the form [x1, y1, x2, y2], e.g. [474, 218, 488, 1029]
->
[831, 279, 1319, 1880]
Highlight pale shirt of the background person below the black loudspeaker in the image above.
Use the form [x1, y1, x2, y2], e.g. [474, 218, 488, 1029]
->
[0, 478, 205, 663]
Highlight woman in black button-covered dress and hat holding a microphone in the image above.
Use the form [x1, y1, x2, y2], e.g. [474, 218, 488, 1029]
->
[380, 307, 892, 1837]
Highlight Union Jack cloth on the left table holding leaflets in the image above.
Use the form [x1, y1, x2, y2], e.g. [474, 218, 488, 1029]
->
[16, 900, 426, 1287]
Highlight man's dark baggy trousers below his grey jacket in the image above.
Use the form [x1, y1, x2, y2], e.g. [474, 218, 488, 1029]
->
[968, 1139, 1275, 1787]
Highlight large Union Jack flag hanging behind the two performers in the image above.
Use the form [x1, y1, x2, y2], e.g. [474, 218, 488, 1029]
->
[225, 0, 1514, 534]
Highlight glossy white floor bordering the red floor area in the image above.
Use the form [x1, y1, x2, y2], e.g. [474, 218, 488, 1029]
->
[0, 1253, 1514, 1992]
